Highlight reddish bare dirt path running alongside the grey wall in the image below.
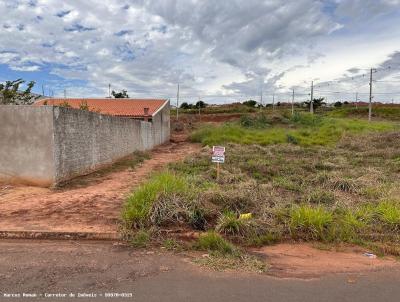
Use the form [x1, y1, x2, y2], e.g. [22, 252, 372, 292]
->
[0, 142, 200, 233]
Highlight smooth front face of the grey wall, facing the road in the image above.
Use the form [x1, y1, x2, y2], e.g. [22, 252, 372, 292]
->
[0, 105, 55, 186]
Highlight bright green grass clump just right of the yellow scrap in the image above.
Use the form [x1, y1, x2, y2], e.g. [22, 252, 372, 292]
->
[290, 205, 333, 239]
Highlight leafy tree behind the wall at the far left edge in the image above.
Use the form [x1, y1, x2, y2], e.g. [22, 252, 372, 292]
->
[0, 79, 35, 105]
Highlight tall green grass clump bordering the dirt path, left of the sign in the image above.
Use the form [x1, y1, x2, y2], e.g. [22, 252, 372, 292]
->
[122, 171, 189, 227]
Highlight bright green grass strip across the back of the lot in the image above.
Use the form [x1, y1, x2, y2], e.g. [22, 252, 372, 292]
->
[191, 114, 395, 146]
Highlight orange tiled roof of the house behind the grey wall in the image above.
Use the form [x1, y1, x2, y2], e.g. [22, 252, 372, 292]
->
[35, 98, 167, 117]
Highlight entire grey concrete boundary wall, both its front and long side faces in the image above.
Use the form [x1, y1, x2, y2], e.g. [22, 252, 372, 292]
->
[0, 105, 169, 186]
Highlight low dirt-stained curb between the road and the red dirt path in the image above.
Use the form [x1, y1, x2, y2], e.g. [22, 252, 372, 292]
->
[0, 230, 121, 240]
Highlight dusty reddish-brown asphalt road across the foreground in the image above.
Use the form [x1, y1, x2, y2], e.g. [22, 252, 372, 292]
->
[0, 240, 400, 302]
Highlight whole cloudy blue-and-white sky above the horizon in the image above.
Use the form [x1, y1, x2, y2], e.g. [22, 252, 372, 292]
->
[0, 0, 400, 104]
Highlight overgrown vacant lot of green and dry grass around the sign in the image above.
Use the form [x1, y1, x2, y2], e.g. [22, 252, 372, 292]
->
[123, 111, 400, 255]
